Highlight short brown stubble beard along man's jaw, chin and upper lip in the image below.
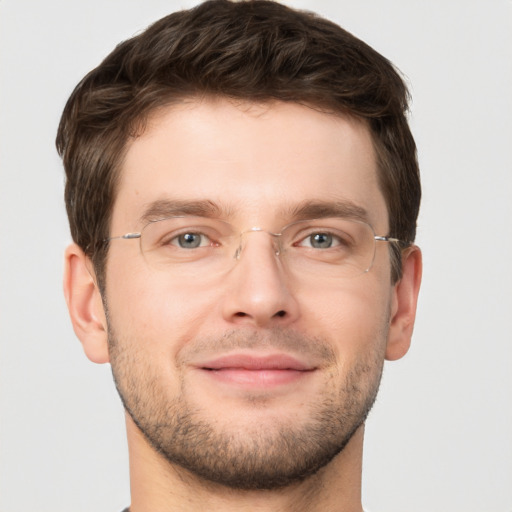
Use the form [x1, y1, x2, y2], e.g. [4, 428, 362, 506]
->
[109, 323, 383, 490]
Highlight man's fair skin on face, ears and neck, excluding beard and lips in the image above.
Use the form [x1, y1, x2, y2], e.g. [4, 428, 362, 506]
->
[64, 99, 421, 512]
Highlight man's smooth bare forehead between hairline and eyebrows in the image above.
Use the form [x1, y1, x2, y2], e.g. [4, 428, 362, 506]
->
[112, 99, 387, 231]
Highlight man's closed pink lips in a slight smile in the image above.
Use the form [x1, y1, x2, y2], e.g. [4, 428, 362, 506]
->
[198, 354, 316, 388]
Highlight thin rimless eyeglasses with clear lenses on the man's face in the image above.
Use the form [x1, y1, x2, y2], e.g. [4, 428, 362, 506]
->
[105, 216, 409, 280]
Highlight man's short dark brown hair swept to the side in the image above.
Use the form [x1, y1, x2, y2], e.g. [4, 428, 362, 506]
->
[56, 0, 421, 286]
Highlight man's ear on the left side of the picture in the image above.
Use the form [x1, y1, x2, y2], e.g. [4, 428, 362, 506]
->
[64, 244, 109, 363]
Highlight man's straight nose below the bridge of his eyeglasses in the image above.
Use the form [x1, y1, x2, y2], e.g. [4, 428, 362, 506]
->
[223, 230, 299, 327]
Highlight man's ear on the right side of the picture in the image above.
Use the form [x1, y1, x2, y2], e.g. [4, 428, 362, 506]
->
[386, 246, 422, 361]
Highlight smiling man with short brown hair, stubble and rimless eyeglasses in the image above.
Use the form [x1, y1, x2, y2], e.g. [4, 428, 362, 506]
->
[57, 0, 421, 512]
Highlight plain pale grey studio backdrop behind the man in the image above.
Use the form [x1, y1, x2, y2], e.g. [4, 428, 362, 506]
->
[0, 0, 512, 512]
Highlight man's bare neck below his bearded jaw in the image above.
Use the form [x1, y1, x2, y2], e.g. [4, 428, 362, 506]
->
[126, 415, 364, 512]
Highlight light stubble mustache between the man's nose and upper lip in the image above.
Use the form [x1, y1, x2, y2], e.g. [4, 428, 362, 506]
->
[177, 328, 336, 366]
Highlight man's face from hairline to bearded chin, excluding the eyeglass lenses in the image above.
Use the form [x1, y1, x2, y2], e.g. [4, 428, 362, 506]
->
[105, 100, 393, 489]
